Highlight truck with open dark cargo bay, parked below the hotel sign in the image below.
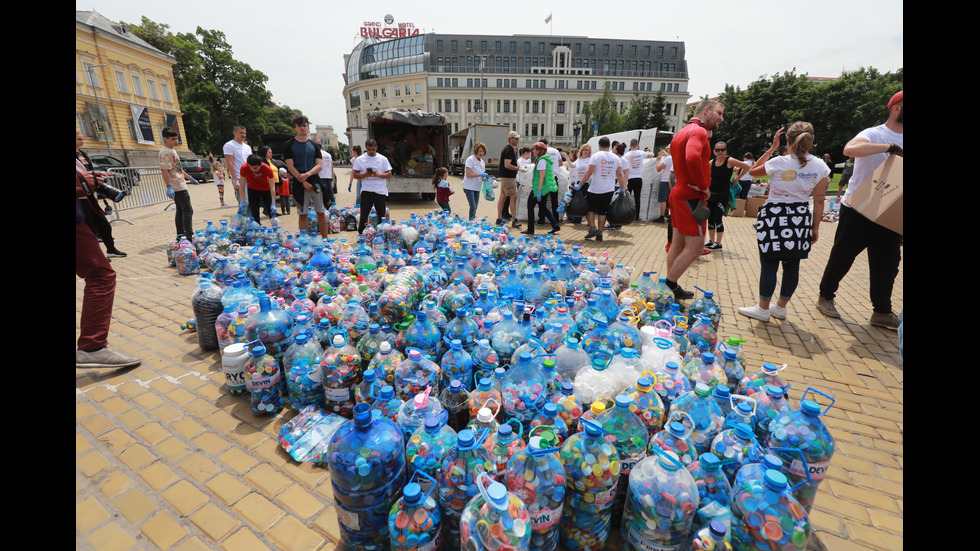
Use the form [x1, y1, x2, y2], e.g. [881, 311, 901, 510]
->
[367, 109, 450, 201]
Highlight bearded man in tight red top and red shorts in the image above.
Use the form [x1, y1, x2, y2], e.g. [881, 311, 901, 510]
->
[667, 100, 725, 300]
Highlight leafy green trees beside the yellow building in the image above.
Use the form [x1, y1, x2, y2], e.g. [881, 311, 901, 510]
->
[129, 17, 299, 156]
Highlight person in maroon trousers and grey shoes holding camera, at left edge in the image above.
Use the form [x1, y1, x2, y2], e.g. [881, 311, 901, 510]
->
[75, 159, 140, 368]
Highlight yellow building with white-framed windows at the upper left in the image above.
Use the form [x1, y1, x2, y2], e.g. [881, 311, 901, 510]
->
[75, 10, 193, 167]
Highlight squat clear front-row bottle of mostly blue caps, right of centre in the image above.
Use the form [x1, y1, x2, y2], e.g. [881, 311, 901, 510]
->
[621, 450, 700, 551]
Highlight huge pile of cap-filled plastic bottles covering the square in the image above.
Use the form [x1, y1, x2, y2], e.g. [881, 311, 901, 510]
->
[174, 207, 834, 550]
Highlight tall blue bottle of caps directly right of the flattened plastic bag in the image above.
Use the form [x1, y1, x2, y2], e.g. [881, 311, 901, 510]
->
[330, 402, 406, 551]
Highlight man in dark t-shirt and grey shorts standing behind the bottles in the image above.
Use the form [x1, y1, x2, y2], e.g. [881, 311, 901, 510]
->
[283, 115, 328, 237]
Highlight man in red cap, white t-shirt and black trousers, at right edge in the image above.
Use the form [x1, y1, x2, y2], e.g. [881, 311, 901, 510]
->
[817, 90, 905, 330]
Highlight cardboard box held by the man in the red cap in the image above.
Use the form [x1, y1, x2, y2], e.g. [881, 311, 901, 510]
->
[847, 155, 905, 235]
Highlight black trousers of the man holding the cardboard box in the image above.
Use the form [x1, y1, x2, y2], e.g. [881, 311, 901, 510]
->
[820, 204, 902, 314]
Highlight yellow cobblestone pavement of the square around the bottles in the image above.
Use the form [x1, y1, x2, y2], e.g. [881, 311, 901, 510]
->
[75, 168, 904, 551]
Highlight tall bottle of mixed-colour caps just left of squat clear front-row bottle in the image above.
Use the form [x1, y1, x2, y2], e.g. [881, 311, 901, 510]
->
[559, 420, 620, 551]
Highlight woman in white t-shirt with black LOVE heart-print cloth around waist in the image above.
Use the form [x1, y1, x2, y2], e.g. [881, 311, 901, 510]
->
[738, 121, 830, 321]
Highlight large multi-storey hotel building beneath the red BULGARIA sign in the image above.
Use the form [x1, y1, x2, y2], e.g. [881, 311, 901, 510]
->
[344, 34, 691, 147]
